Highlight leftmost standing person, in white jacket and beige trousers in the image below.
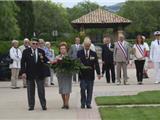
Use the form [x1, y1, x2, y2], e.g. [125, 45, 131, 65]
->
[9, 40, 22, 89]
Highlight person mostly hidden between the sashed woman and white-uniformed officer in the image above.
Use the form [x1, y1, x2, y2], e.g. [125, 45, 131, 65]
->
[142, 36, 149, 78]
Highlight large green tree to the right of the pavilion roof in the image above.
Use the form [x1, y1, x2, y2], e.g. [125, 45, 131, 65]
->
[119, 1, 160, 37]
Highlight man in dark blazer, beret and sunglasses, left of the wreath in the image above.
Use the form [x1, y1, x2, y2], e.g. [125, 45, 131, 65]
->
[21, 39, 47, 111]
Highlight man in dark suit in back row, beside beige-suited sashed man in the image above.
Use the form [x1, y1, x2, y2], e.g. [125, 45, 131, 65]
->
[102, 36, 115, 83]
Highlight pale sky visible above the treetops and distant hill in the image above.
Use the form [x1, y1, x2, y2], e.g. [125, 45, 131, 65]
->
[52, 0, 126, 8]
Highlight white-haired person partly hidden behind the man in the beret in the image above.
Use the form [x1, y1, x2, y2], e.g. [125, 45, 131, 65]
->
[19, 38, 30, 88]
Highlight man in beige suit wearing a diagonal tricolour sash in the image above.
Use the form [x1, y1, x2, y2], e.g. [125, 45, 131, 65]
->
[113, 35, 129, 85]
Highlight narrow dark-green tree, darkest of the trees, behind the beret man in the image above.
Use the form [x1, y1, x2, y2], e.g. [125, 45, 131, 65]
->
[16, 1, 35, 38]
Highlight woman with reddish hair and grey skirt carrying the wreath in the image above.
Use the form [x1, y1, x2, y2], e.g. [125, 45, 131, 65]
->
[52, 42, 72, 109]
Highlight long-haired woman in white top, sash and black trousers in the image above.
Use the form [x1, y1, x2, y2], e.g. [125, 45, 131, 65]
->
[133, 35, 145, 85]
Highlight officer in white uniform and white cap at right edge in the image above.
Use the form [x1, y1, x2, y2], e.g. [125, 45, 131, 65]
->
[150, 31, 160, 84]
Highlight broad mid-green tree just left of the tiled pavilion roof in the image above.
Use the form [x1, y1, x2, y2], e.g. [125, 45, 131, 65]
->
[34, 1, 71, 39]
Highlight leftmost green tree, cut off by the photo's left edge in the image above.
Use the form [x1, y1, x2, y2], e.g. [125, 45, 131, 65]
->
[0, 1, 20, 40]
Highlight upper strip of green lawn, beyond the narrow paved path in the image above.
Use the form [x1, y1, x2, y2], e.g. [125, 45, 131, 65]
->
[96, 91, 160, 105]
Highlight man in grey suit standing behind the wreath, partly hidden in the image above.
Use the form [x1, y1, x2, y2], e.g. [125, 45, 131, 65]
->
[68, 37, 83, 82]
